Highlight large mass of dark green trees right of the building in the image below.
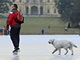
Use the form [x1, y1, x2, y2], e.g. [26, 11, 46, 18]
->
[54, 0, 80, 27]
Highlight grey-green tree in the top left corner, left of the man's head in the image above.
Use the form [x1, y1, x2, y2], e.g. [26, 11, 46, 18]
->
[0, 0, 12, 13]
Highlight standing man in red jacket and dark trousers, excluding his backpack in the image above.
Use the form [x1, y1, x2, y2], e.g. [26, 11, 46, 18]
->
[6, 4, 21, 53]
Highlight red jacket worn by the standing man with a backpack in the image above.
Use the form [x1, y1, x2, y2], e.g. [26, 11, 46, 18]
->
[7, 10, 18, 26]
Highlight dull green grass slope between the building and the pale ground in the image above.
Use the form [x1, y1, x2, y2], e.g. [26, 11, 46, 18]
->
[0, 17, 79, 34]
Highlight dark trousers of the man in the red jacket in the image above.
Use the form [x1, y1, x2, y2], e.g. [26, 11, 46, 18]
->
[10, 24, 21, 49]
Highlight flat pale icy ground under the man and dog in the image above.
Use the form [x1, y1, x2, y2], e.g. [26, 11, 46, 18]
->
[0, 35, 80, 60]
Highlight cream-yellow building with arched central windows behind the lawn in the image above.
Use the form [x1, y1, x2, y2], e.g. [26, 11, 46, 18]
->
[12, 0, 59, 16]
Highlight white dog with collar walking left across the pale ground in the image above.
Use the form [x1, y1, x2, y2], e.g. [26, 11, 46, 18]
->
[48, 39, 77, 55]
